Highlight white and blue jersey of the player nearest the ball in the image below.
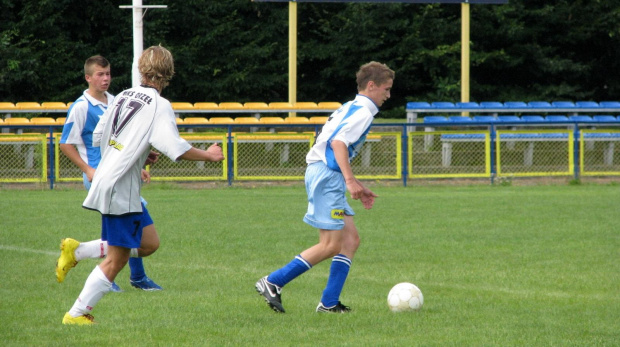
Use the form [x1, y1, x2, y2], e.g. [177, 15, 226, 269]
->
[306, 94, 379, 172]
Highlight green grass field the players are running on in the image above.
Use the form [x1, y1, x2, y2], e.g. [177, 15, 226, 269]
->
[0, 184, 620, 346]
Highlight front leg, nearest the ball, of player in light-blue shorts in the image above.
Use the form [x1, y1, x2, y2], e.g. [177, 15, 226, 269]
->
[317, 215, 360, 313]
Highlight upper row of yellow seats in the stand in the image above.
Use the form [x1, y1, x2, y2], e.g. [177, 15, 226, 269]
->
[0, 102, 342, 113]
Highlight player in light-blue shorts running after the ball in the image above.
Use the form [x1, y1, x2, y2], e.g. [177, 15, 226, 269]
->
[255, 62, 394, 313]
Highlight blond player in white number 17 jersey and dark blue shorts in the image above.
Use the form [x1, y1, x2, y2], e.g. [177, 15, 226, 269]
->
[62, 46, 224, 325]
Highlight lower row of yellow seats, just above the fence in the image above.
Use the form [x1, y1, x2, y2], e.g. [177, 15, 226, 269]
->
[0, 116, 327, 125]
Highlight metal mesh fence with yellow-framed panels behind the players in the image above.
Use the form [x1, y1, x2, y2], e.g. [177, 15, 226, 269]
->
[0, 122, 620, 188]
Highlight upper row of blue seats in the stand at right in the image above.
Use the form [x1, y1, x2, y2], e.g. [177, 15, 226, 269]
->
[407, 101, 620, 111]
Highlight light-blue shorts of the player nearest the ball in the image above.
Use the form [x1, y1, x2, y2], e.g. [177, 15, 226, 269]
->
[304, 161, 355, 230]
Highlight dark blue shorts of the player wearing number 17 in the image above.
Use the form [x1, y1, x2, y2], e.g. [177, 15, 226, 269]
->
[101, 204, 153, 248]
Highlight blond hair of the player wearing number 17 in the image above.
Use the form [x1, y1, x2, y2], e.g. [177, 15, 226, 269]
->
[138, 45, 174, 91]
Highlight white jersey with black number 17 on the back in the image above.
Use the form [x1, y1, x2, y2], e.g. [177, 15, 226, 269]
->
[83, 86, 192, 215]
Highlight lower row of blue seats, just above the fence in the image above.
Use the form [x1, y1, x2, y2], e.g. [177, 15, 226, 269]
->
[424, 115, 620, 123]
